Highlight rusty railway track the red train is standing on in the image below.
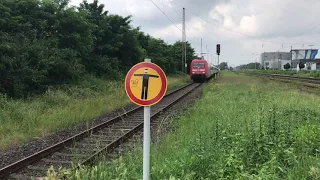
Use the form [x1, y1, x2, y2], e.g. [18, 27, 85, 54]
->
[0, 83, 202, 179]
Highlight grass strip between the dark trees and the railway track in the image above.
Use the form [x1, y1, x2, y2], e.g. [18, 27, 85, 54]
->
[0, 75, 188, 150]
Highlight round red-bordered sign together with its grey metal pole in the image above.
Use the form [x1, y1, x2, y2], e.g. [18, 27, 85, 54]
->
[125, 59, 168, 180]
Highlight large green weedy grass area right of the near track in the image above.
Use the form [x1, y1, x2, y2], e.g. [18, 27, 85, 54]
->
[53, 72, 320, 179]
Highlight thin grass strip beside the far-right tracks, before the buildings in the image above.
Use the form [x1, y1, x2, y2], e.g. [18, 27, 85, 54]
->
[242, 70, 320, 77]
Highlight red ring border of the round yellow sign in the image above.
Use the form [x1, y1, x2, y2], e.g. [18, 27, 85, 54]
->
[125, 62, 168, 106]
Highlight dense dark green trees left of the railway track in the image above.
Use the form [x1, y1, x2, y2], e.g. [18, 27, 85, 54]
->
[0, 0, 196, 98]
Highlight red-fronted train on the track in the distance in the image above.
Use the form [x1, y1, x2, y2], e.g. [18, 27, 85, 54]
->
[190, 59, 219, 82]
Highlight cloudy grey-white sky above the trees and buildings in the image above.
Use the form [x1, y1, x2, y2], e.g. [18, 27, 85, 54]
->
[71, 0, 320, 67]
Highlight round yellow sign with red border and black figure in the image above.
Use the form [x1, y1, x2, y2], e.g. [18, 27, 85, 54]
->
[125, 62, 167, 106]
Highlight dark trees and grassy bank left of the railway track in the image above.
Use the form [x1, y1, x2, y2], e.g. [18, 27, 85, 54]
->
[0, 0, 196, 150]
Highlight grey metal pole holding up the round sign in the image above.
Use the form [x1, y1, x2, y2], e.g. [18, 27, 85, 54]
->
[143, 59, 151, 180]
